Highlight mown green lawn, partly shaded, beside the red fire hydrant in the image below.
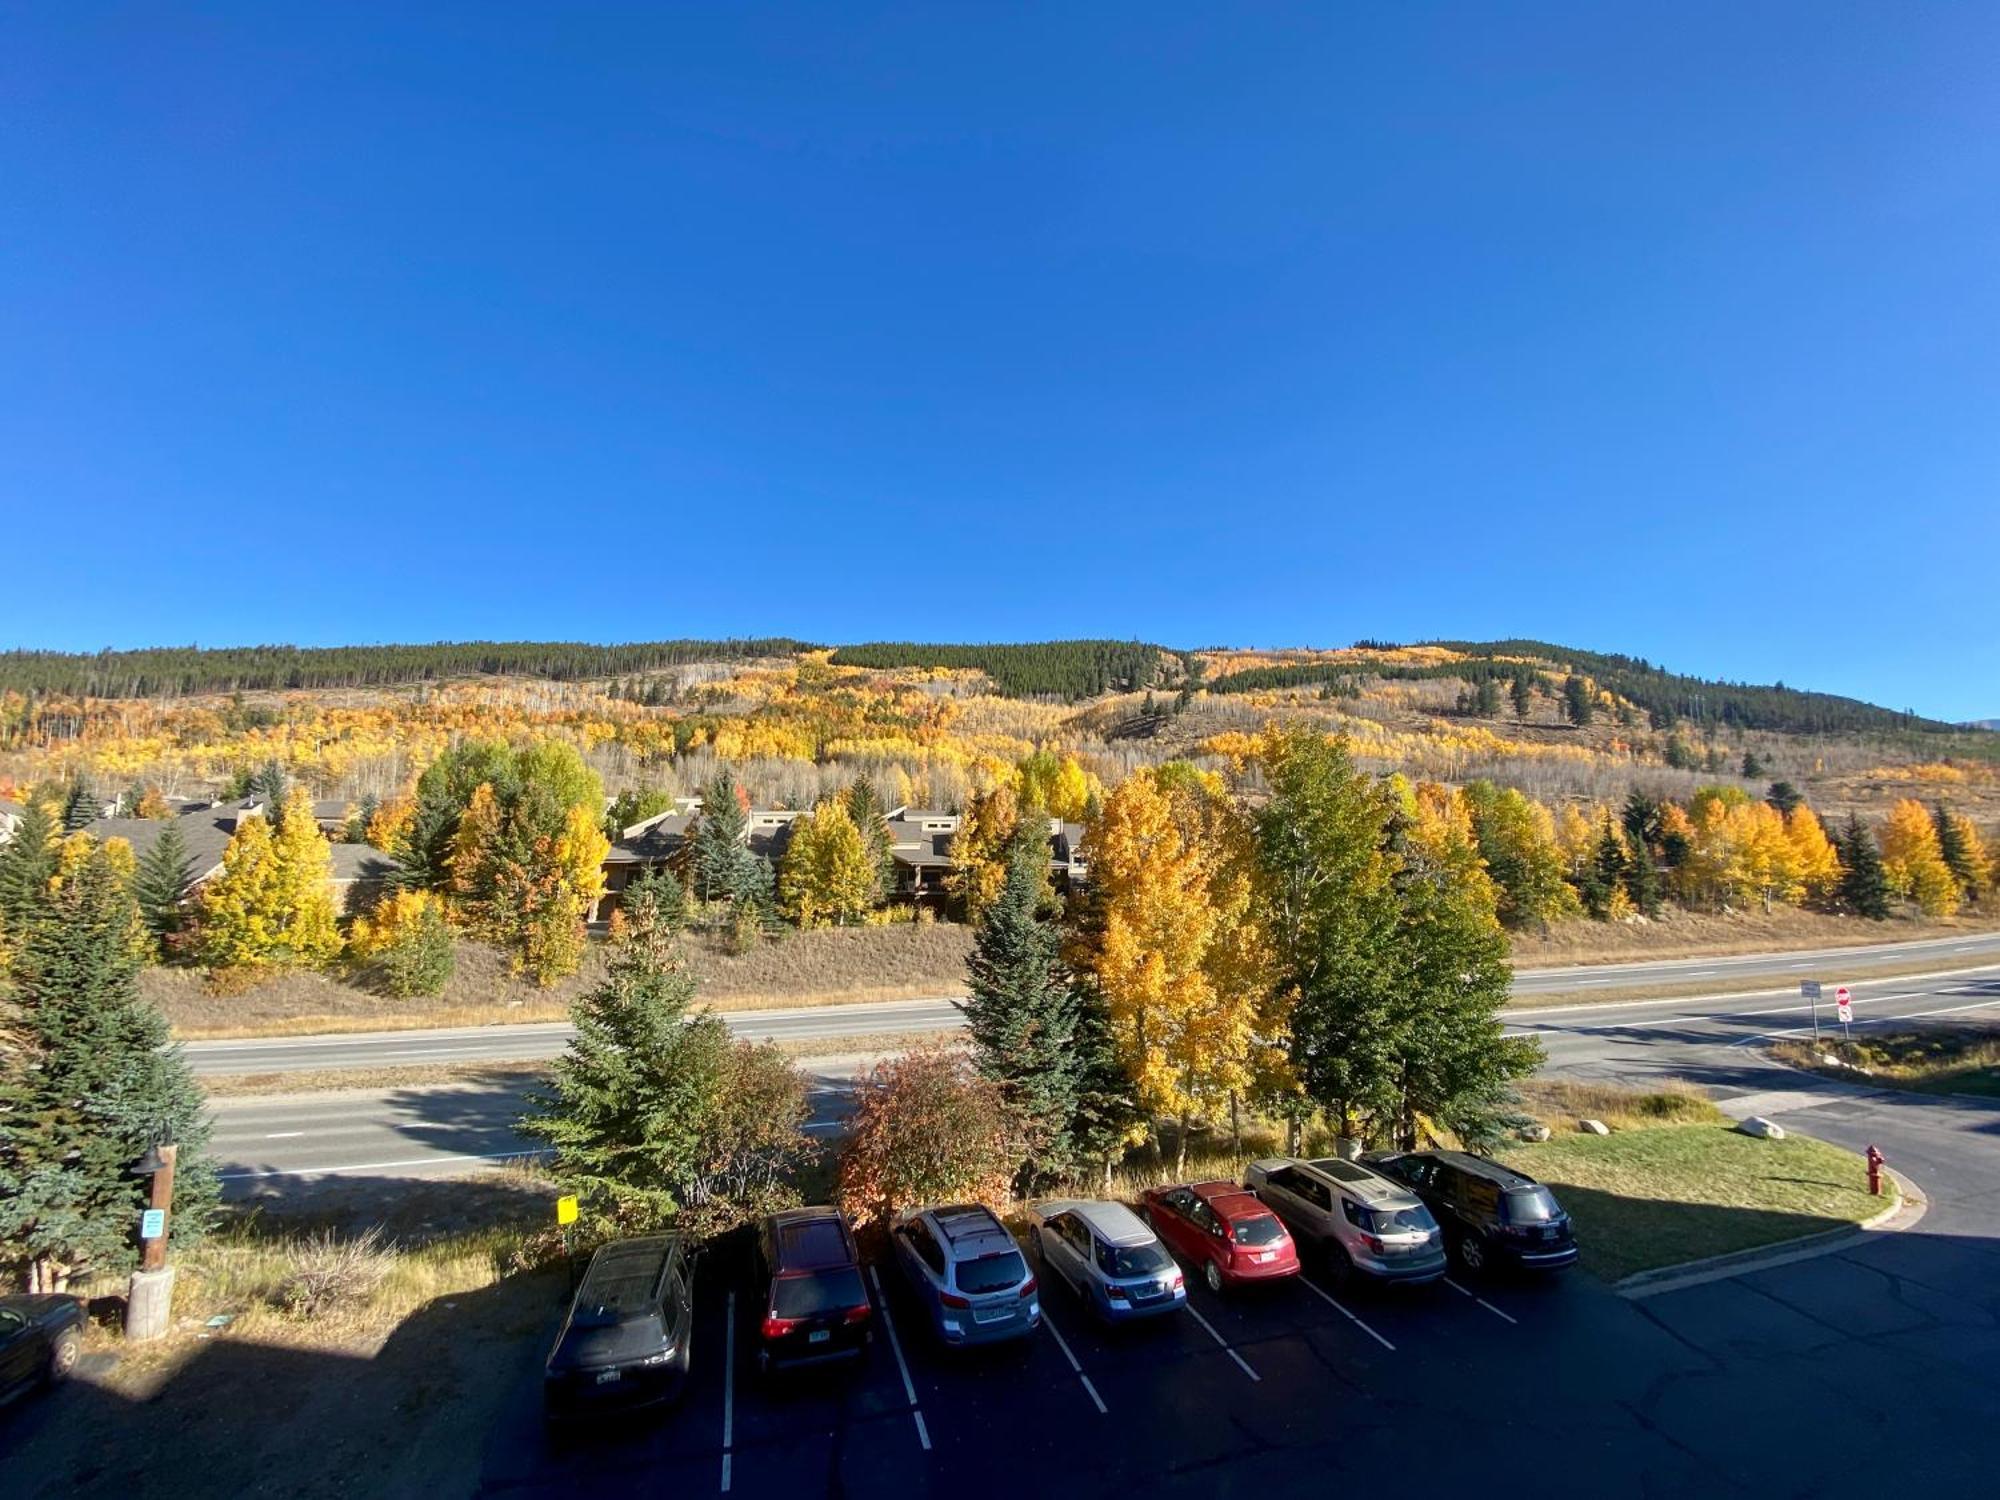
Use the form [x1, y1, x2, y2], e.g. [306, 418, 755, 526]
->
[1500, 1124, 1888, 1280]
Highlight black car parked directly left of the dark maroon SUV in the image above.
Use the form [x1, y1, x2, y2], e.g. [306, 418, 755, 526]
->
[542, 1234, 694, 1420]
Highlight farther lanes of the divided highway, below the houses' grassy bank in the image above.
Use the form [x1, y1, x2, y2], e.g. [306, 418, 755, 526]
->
[186, 932, 2000, 1074]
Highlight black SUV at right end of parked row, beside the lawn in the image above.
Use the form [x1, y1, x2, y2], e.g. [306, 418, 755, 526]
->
[1362, 1152, 1576, 1272]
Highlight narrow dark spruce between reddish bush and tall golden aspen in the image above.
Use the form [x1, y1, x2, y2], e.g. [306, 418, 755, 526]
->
[964, 830, 1078, 1192]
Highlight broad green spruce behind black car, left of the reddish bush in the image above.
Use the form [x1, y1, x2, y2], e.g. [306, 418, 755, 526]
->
[522, 874, 730, 1224]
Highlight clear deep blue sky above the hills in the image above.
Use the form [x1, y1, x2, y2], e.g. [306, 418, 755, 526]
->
[0, 0, 2000, 718]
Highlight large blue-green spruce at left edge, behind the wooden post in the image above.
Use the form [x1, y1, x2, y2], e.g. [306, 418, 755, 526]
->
[0, 848, 216, 1292]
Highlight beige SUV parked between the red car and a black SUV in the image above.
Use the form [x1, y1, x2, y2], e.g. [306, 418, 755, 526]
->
[1244, 1156, 1446, 1282]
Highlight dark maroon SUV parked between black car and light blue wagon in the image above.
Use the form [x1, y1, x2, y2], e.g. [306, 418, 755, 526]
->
[756, 1208, 874, 1372]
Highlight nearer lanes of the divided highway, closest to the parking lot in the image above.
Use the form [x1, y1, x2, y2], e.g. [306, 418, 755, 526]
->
[214, 968, 2000, 1196]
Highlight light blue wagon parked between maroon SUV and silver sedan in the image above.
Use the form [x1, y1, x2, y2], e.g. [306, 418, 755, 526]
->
[890, 1204, 1042, 1344]
